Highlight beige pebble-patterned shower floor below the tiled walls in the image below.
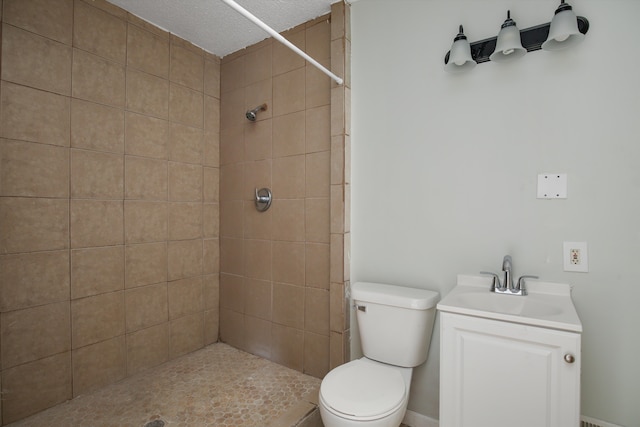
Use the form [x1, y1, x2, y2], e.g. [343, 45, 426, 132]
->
[9, 343, 320, 427]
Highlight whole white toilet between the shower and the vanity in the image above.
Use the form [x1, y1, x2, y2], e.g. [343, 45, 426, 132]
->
[319, 282, 439, 427]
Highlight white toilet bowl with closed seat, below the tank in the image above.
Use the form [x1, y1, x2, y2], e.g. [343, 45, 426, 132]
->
[319, 357, 412, 427]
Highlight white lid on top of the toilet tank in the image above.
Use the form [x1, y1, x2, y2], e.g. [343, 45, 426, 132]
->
[351, 282, 440, 310]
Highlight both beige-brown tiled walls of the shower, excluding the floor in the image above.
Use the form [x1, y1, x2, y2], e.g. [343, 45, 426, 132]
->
[0, 0, 350, 424]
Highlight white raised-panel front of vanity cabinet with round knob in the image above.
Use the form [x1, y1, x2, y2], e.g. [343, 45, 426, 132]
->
[440, 310, 580, 427]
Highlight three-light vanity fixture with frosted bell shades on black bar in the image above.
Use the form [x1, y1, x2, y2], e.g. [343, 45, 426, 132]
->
[444, 0, 589, 73]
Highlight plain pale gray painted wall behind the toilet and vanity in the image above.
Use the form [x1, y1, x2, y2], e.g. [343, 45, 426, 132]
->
[351, 0, 640, 426]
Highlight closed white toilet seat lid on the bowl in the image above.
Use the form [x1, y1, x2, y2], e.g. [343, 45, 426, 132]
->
[320, 359, 407, 421]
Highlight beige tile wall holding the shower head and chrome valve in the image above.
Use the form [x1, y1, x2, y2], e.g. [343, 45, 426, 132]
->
[220, 3, 349, 377]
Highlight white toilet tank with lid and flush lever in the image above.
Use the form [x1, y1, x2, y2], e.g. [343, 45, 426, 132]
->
[351, 282, 439, 368]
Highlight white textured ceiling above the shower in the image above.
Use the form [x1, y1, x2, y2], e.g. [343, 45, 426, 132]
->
[108, 0, 340, 57]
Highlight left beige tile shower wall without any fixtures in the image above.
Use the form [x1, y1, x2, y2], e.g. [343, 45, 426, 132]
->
[0, 0, 220, 424]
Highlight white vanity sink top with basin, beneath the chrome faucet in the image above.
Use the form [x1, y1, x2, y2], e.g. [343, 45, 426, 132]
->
[438, 275, 582, 332]
